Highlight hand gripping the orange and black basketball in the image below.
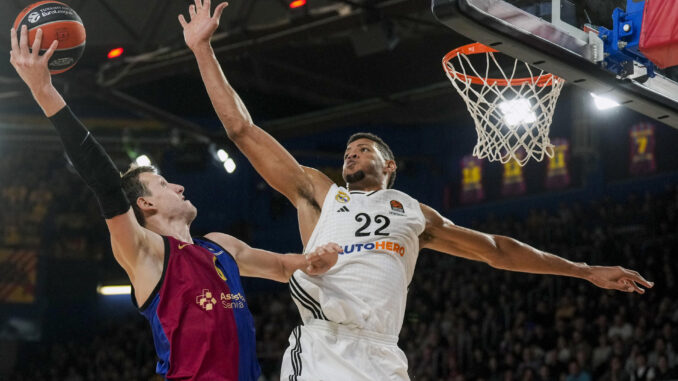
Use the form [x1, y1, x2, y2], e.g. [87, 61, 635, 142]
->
[9, 25, 59, 93]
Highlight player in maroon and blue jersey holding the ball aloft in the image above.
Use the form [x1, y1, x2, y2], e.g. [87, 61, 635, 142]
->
[10, 21, 341, 381]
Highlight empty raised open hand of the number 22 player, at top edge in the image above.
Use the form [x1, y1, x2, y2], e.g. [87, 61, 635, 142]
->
[179, 0, 228, 50]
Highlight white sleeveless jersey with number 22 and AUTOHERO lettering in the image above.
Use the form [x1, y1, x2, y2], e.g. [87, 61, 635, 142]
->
[290, 185, 426, 337]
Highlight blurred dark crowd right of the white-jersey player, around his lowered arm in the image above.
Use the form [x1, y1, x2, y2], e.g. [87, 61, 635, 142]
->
[400, 189, 678, 381]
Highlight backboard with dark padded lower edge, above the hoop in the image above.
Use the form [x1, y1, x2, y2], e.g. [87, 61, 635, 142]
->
[432, 0, 678, 128]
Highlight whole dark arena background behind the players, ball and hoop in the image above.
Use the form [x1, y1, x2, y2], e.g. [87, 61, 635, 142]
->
[0, 0, 678, 381]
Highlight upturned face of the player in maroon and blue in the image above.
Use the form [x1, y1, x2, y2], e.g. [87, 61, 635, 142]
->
[139, 172, 197, 223]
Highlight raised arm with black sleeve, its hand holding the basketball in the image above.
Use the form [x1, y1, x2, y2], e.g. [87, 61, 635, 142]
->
[10, 26, 164, 293]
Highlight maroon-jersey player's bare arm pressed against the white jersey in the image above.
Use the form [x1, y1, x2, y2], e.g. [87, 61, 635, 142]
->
[205, 233, 342, 283]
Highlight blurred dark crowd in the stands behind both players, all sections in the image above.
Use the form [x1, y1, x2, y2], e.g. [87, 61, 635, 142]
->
[0, 144, 678, 381]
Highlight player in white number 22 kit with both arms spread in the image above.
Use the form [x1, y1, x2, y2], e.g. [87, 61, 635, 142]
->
[179, 0, 652, 381]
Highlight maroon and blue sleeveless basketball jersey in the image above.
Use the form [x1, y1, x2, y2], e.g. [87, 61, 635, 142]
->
[132, 237, 261, 381]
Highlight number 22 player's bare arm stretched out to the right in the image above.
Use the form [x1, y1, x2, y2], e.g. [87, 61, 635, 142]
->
[419, 204, 654, 294]
